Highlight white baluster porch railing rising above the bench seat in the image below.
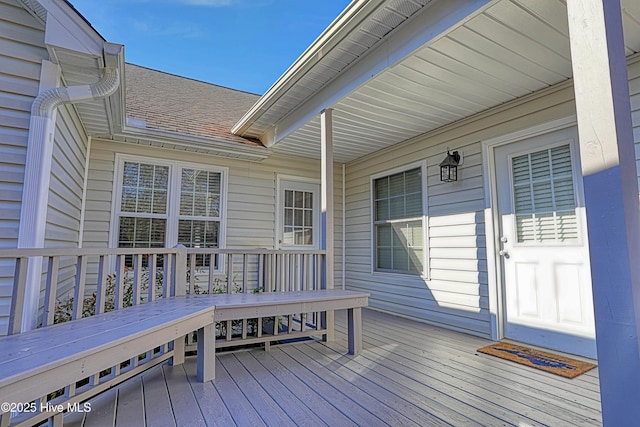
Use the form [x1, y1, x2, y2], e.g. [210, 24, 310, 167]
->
[0, 247, 325, 335]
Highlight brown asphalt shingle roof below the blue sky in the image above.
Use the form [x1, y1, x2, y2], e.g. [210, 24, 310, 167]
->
[125, 64, 262, 146]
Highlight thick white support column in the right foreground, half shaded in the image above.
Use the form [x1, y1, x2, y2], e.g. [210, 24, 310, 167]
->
[566, 0, 640, 426]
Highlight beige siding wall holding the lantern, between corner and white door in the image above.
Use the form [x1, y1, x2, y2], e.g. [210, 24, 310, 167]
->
[346, 83, 574, 337]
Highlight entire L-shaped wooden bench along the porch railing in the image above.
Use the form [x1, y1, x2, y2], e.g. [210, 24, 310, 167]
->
[0, 290, 369, 427]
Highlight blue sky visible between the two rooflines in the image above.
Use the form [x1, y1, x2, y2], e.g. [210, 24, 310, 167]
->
[70, 0, 350, 94]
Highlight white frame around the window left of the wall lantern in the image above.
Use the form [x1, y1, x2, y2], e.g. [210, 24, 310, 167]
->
[369, 160, 430, 280]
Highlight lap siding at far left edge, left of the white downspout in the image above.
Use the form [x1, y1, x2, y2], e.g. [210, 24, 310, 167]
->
[0, 0, 47, 335]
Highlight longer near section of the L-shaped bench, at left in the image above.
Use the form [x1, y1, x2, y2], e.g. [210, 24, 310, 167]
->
[0, 296, 215, 425]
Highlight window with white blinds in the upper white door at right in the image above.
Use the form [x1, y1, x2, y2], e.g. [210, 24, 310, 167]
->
[511, 144, 578, 243]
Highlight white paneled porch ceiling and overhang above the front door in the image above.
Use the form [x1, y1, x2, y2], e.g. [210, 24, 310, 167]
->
[233, 0, 640, 162]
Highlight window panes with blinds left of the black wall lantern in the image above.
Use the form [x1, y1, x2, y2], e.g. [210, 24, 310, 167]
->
[372, 166, 426, 274]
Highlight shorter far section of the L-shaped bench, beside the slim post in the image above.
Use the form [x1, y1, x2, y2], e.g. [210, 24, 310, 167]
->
[198, 290, 369, 380]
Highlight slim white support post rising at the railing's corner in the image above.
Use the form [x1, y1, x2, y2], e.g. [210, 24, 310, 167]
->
[320, 108, 334, 341]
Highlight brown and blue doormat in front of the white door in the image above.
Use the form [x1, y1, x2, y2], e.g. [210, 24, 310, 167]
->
[478, 342, 596, 378]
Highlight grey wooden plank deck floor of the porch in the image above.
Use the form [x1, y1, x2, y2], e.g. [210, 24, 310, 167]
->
[65, 310, 602, 427]
